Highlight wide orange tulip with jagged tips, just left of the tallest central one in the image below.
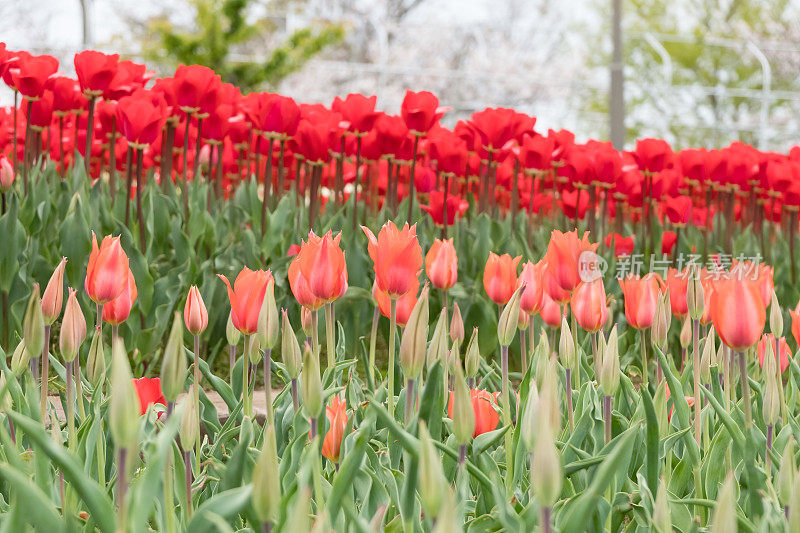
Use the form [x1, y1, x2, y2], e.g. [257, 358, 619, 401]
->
[292, 231, 347, 303]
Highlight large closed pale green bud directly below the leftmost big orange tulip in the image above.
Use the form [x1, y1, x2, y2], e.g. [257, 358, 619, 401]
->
[109, 337, 139, 449]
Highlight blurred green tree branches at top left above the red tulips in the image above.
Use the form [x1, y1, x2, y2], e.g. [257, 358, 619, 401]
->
[145, 0, 344, 91]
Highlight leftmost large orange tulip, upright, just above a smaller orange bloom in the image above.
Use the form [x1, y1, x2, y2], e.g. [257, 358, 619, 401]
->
[84, 232, 128, 305]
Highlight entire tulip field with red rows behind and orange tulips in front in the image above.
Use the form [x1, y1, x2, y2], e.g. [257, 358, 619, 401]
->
[0, 44, 800, 533]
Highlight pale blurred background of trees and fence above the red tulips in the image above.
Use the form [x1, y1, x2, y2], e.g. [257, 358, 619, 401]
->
[0, 0, 800, 151]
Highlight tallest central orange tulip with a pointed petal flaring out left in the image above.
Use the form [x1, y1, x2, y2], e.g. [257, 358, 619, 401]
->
[361, 221, 422, 298]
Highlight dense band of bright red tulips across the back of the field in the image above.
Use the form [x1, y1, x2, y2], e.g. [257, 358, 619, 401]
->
[0, 43, 800, 229]
